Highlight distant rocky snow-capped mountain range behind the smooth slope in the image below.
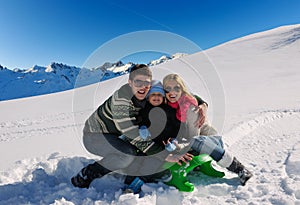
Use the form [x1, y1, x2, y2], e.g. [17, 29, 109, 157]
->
[0, 54, 185, 101]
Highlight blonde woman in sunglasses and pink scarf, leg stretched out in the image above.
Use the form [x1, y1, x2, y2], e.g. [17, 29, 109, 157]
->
[163, 74, 252, 185]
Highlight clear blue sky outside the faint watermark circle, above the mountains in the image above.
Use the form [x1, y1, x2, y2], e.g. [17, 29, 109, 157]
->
[0, 0, 300, 69]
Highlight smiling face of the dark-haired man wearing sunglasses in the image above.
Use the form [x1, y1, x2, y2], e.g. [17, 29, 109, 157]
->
[128, 75, 151, 100]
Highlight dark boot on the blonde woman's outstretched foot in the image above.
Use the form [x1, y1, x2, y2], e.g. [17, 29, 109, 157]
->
[227, 157, 253, 186]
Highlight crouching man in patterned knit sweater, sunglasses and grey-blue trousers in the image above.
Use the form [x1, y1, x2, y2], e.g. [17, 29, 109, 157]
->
[71, 64, 152, 188]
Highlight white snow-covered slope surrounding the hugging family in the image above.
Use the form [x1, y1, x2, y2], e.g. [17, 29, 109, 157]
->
[0, 25, 300, 205]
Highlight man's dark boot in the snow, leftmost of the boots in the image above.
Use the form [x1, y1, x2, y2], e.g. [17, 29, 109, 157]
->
[71, 162, 102, 188]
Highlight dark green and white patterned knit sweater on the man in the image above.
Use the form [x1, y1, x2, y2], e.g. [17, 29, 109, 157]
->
[83, 84, 152, 151]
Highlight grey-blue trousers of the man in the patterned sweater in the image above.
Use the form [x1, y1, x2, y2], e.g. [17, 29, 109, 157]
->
[83, 133, 166, 177]
